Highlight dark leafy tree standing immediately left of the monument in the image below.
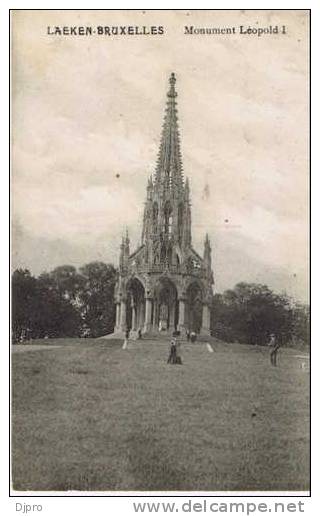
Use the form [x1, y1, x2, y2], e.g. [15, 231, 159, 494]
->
[79, 262, 117, 337]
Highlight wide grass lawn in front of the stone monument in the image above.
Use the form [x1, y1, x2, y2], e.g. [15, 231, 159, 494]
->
[12, 339, 309, 491]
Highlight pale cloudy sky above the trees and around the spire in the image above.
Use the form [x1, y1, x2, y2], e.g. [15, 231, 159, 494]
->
[12, 11, 309, 301]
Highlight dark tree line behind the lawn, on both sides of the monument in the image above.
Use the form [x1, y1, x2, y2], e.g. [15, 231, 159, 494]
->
[12, 262, 310, 346]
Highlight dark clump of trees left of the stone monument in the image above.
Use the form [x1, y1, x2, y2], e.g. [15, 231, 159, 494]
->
[11, 262, 117, 341]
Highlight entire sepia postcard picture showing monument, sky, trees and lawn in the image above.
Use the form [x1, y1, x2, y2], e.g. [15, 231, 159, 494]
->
[10, 9, 310, 496]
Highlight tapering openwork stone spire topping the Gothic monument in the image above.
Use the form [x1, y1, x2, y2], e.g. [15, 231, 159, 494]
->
[155, 73, 183, 189]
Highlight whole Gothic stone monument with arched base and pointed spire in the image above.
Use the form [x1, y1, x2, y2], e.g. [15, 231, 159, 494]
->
[115, 73, 213, 335]
